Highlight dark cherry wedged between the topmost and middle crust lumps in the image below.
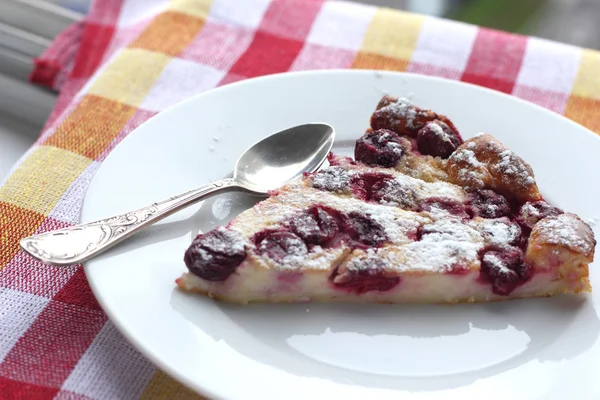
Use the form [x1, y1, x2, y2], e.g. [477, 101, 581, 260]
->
[417, 120, 461, 158]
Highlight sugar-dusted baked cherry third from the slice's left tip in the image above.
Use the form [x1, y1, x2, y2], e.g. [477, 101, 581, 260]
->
[290, 206, 341, 245]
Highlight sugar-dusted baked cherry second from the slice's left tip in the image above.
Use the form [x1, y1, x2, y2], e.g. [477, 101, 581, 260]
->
[254, 230, 308, 263]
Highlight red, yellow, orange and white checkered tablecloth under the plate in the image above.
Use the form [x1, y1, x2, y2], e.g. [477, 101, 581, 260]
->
[0, 0, 600, 399]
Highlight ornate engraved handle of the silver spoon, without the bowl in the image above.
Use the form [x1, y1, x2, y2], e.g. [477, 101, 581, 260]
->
[21, 179, 240, 265]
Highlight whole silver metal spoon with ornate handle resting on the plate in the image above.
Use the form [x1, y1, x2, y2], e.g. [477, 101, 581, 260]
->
[21, 123, 335, 265]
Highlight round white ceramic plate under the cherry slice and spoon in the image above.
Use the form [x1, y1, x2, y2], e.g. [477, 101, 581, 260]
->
[83, 71, 600, 400]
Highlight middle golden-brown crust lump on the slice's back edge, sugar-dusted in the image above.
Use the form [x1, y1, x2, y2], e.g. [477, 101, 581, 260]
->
[447, 134, 542, 203]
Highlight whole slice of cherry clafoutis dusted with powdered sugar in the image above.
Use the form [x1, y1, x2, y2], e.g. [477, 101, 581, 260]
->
[177, 97, 596, 304]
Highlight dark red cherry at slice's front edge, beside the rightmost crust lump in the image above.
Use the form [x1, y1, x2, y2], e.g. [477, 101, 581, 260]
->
[480, 247, 532, 296]
